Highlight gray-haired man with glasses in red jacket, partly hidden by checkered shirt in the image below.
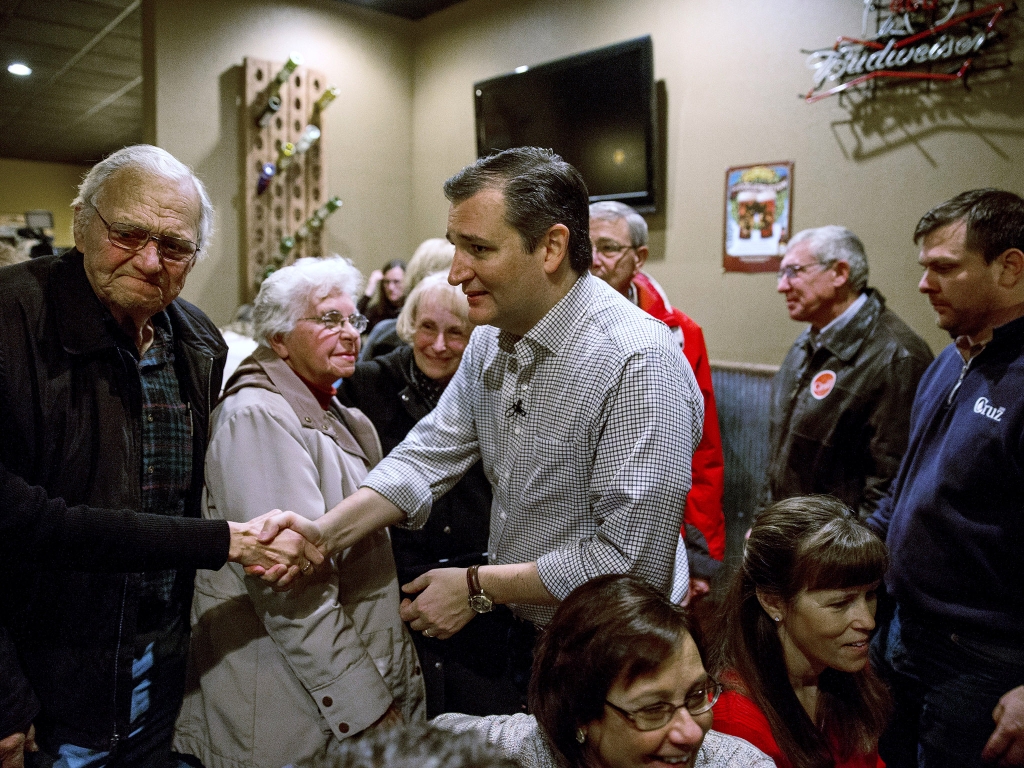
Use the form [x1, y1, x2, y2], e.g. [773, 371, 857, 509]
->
[590, 201, 725, 604]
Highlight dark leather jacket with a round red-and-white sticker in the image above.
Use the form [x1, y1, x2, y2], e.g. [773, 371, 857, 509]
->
[763, 288, 932, 520]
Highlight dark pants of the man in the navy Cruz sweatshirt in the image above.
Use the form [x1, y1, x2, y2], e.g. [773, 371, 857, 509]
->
[871, 607, 1024, 768]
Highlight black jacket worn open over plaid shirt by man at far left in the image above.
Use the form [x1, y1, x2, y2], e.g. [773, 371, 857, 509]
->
[0, 250, 227, 751]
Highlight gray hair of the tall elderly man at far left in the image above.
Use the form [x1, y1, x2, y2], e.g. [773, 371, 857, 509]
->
[71, 144, 213, 257]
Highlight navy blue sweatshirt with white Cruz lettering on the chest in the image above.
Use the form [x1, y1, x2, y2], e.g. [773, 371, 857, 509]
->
[867, 317, 1024, 644]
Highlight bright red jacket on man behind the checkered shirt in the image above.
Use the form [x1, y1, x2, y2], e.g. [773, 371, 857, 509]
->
[633, 272, 725, 560]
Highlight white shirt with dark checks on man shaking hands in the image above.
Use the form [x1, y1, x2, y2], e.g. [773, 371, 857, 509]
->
[364, 275, 703, 625]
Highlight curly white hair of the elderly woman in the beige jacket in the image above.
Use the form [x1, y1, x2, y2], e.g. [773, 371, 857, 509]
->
[253, 256, 362, 346]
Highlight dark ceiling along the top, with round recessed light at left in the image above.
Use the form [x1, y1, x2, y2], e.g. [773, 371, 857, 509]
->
[0, 0, 461, 164]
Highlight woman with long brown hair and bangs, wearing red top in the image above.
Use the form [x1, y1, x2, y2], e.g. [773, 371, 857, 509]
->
[712, 496, 890, 768]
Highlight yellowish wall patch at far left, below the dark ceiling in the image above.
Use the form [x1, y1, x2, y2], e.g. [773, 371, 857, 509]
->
[0, 158, 89, 248]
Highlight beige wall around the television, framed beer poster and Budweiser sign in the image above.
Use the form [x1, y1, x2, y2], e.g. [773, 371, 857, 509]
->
[413, 0, 1024, 364]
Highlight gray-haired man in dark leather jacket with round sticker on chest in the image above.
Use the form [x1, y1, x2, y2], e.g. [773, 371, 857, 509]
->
[763, 225, 932, 520]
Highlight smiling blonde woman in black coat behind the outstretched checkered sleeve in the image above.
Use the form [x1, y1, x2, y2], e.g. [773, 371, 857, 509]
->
[338, 274, 520, 717]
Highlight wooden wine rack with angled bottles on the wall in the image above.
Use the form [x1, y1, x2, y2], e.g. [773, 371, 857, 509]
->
[242, 57, 330, 301]
